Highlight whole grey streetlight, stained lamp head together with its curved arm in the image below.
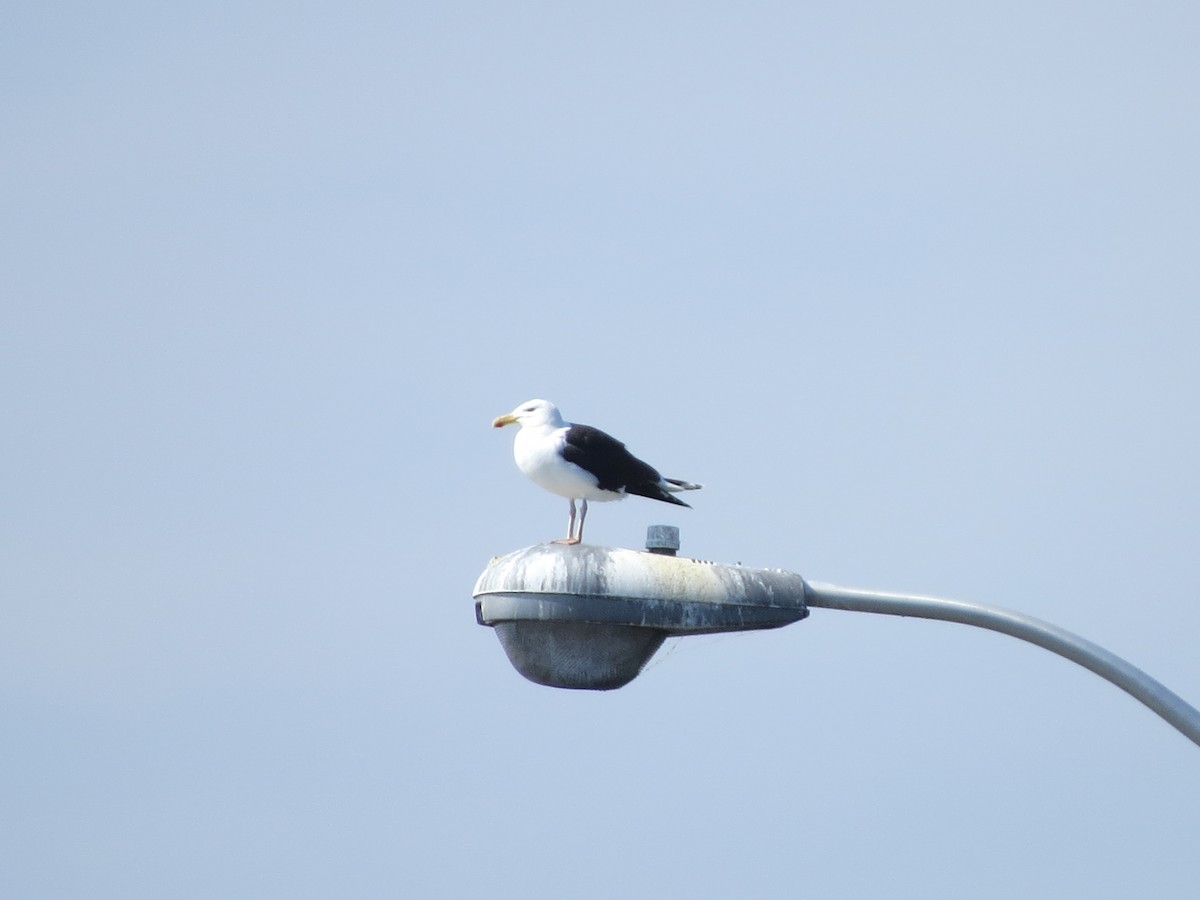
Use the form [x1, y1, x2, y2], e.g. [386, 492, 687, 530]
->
[474, 526, 1200, 745]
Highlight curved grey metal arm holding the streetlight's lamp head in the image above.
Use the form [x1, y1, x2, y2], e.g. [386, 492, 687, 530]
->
[805, 582, 1200, 745]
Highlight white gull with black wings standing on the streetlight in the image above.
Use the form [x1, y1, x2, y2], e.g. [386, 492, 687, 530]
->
[492, 400, 702, 544]
